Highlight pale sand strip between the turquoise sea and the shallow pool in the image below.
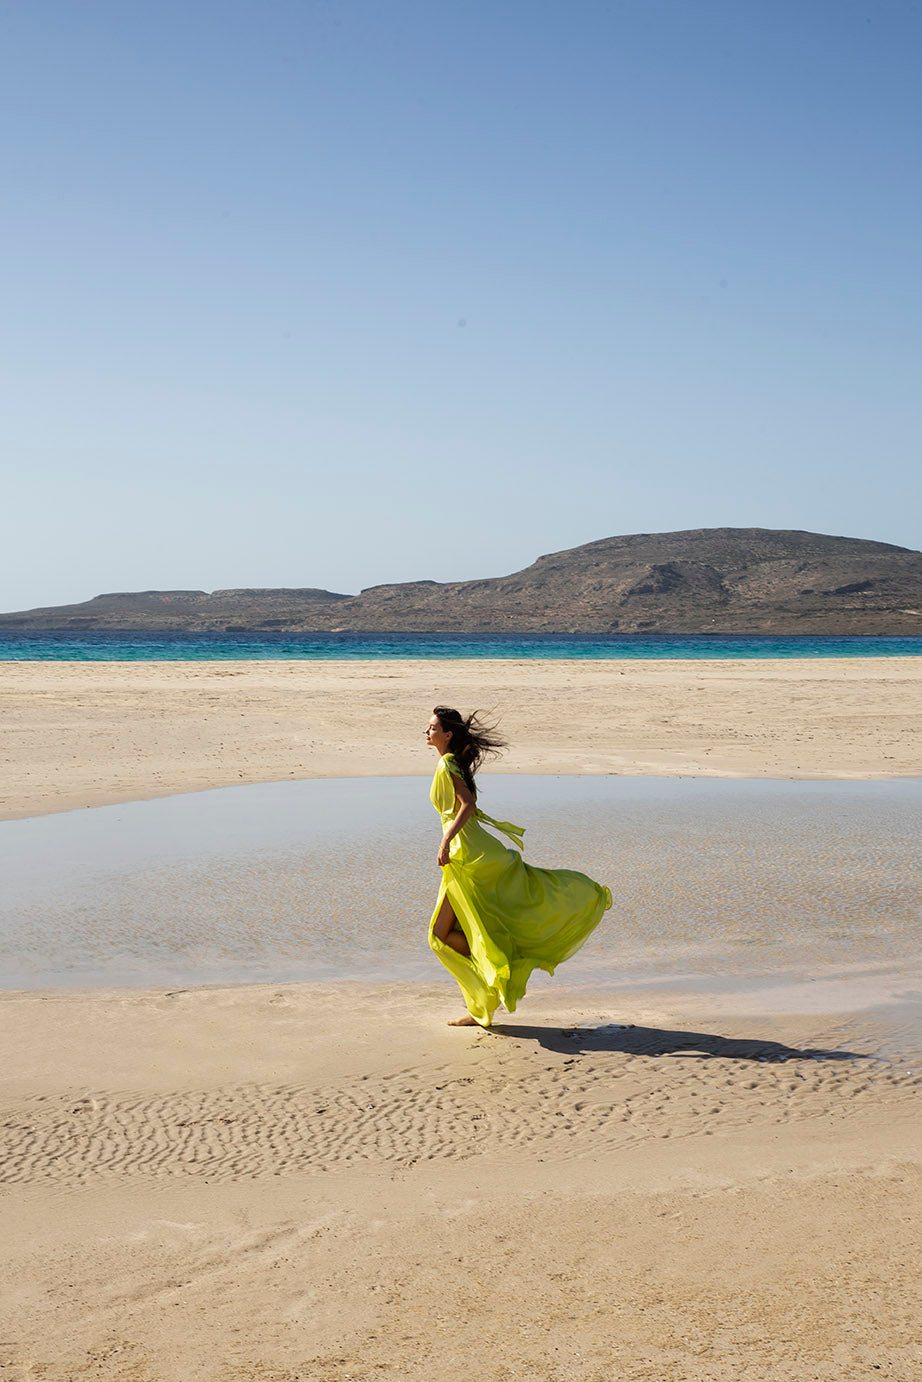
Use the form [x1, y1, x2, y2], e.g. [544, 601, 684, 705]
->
[0, 658, 922, 818]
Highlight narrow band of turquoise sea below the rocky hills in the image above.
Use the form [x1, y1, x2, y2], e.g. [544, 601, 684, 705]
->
[0, 629, 922, 662]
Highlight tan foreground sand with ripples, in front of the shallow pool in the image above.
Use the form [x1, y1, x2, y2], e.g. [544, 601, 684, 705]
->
[0, 984, 922, 1382]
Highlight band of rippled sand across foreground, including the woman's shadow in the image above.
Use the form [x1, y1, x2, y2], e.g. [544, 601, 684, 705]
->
[0, 1027, 922, 1186]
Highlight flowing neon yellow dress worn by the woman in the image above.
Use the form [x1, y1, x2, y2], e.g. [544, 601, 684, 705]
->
[429, 753, 611, 1027]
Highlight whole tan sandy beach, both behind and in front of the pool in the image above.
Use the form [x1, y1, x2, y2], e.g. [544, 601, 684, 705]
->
[0, 659, 922, 1382]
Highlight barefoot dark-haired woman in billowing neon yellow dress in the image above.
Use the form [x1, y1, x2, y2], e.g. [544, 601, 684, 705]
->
[426, 705, 611, 1027]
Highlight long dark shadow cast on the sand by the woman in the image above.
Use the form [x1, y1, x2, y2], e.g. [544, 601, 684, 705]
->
[489, 1023, 871, 1063]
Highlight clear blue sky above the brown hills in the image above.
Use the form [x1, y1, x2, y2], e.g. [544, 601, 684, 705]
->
[0, 0, 922, 609]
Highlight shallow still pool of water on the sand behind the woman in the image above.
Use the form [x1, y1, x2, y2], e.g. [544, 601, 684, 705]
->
[0, 774, 922, 1007]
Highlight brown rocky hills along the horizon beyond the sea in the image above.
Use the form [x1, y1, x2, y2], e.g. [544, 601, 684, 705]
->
[0, 528, 922, 634]
